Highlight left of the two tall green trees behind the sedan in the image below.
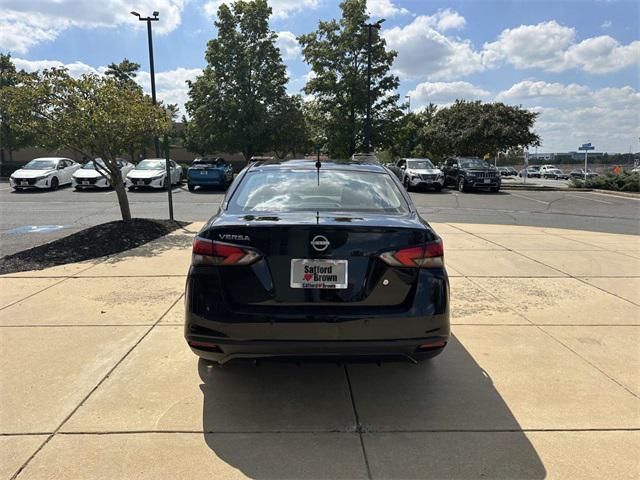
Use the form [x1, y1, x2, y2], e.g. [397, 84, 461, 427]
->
[186, 0, 287, 161]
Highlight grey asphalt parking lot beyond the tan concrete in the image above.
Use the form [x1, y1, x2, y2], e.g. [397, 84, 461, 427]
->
[0, 180, 640, 256]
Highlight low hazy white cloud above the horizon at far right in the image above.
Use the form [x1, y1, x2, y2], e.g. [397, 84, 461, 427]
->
[496, 80, 640, 152]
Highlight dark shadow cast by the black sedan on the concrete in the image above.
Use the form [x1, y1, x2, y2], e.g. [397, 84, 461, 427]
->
[199, 338, 546, 479]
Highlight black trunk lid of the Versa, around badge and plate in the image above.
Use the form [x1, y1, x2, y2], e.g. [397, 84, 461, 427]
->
[200, 212, 437, 308]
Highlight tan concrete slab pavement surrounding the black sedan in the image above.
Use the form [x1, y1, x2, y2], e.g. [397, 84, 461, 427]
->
[0, 222, 640, 479]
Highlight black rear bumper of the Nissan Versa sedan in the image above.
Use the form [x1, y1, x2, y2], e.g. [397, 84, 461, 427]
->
[184, 271, 450, 362]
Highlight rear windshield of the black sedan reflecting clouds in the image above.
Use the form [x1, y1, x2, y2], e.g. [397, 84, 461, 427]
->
[229, 170, 409, 214]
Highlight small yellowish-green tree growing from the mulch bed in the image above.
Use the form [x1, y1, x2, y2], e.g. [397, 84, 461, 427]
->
[0, 68, 170, 221]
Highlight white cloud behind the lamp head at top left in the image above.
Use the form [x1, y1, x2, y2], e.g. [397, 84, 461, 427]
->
[0, 0, 187, 53]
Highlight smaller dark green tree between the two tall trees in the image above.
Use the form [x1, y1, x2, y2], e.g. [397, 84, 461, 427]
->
[270, 95, 310, 158]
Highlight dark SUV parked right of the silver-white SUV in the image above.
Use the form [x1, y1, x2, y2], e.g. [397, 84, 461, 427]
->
[442, 157, 502, 192]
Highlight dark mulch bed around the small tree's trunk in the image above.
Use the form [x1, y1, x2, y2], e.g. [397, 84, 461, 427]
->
[0, 218, 188, 275]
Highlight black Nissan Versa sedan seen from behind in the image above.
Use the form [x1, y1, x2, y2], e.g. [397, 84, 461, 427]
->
[185, 160, 449, 363]
